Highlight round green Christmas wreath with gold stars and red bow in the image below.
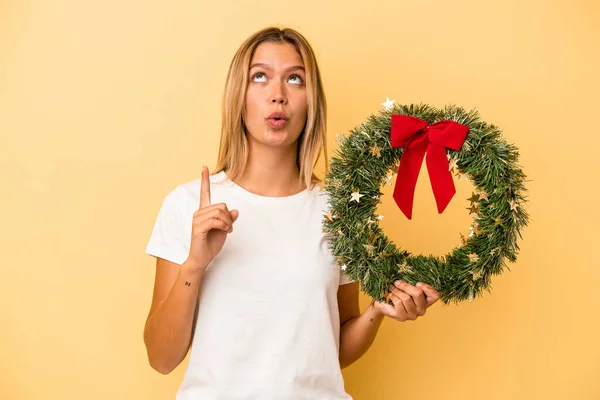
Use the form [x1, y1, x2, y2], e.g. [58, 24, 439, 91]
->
[323, 99, 529, 304]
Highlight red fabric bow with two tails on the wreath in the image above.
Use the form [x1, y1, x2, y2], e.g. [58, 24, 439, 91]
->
[390, 114, 469, 219]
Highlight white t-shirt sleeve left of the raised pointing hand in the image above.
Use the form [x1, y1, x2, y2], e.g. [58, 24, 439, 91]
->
[146, 186, 189, 265]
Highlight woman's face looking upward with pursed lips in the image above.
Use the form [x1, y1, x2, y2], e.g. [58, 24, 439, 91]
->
[244, 42, 307, 147]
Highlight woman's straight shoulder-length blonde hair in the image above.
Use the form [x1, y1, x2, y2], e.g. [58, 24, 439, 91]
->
[212, 27, 328, 189]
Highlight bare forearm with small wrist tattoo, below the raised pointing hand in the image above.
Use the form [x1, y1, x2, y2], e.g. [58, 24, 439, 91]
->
[144, 258, 204, 374]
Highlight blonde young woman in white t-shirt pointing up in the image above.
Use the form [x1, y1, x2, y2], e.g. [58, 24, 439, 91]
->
[144, 28, 439, 400]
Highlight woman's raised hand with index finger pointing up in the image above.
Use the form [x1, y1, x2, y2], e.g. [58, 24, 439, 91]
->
[188, 166, 239, 269]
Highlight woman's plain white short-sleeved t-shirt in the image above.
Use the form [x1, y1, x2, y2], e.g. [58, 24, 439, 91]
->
[146, 172, 352, 400]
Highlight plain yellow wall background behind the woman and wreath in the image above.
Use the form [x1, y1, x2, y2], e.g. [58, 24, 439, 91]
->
[0, 0, 600, 400]
